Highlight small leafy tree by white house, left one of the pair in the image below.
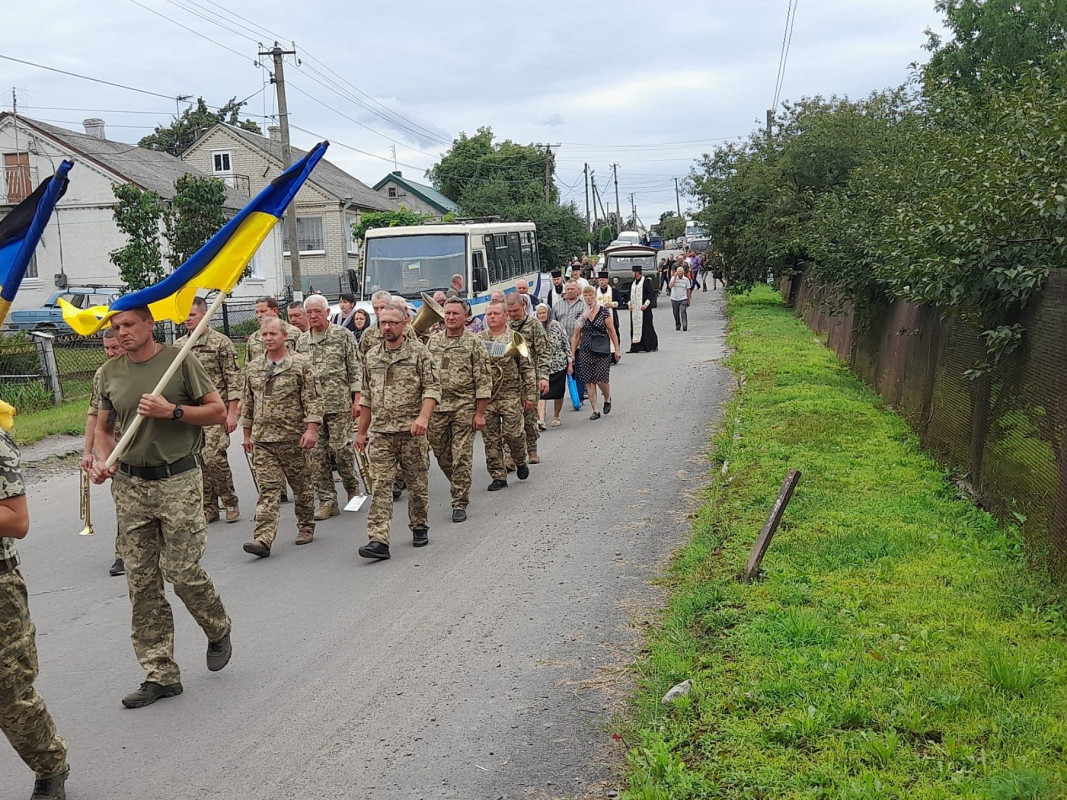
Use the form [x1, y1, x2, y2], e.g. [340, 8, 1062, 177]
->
[109, 183, 163, 291]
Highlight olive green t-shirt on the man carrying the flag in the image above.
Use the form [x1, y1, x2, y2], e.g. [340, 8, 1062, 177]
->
[99, 345, 216, 466]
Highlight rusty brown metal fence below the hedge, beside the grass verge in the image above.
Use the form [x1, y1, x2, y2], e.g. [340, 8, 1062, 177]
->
[782, 270, 1067, 576]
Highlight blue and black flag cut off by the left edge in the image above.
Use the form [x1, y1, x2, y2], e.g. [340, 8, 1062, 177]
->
[0, 161, 74, 323]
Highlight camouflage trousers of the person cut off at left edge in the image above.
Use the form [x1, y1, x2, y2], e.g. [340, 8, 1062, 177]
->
[0, 570, 66, 778]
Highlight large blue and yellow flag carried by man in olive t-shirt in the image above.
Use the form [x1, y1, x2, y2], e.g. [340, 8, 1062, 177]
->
[60, 142, 330, 336]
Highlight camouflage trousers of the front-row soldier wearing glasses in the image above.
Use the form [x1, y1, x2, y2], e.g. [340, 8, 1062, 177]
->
[367, 432, 430, 544]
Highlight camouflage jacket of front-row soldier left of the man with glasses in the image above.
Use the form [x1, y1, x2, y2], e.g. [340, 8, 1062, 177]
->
[240, 353, 322, 442]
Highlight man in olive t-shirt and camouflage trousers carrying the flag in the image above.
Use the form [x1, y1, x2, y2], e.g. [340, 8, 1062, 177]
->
[90, 308, 232, 708]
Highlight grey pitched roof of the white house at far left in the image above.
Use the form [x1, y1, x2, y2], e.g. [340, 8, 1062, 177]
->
[0, 111, 249, 211]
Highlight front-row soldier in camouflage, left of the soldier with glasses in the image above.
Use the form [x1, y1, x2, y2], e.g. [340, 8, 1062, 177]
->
[241, 319, 322, 558]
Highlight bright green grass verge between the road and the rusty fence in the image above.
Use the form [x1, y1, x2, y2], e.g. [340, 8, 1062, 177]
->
[620, 289, 1067, 800]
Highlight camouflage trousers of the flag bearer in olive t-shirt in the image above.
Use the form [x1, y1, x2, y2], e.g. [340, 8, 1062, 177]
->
[111, 468, 230, 685]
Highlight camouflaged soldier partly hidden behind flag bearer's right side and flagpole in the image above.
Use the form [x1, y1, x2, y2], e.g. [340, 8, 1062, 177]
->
[174, 298, 241, 523]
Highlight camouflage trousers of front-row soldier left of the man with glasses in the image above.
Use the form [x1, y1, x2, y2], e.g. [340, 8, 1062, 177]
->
[252, 439, 315, 547]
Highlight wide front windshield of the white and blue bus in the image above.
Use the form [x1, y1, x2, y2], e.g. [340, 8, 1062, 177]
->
[363, 234, 466, 297]
